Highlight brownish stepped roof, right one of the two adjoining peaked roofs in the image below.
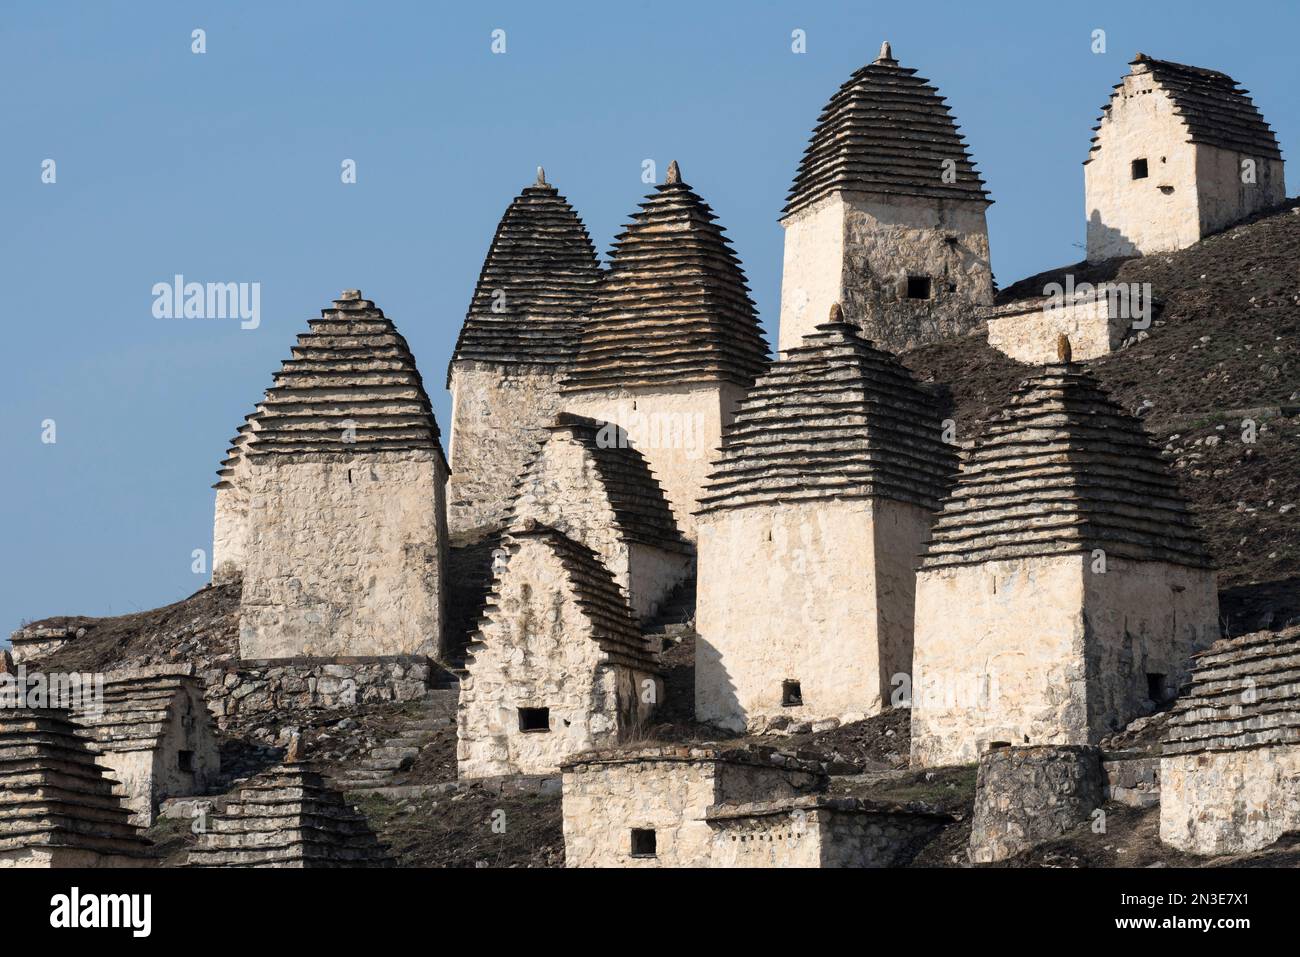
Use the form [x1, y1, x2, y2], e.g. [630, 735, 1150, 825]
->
[566, 161, 767, 390]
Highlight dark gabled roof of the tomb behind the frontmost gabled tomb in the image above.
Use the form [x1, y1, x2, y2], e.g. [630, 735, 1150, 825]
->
[506, 412, 692, 551]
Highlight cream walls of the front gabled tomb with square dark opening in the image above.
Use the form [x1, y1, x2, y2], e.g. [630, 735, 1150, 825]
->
[456, 538, 663, 778]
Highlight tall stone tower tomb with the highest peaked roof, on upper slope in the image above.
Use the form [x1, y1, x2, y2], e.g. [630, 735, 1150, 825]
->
[779, 43, 993, 352]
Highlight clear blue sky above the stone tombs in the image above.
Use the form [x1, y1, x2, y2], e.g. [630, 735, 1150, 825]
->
[0, 0, 1300, 635]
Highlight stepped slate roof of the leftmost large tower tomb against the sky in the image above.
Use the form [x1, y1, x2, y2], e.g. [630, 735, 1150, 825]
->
[236, 289, 442, 468]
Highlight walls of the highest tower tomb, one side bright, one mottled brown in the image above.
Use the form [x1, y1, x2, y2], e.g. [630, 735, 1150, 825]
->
[777, 191, 993, 352]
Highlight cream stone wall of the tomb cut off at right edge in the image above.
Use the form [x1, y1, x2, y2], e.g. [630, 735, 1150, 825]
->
[1160, 745, 1300, 854]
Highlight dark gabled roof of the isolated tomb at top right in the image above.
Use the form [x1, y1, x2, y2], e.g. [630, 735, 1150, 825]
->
[1084, 53, 1282, 165]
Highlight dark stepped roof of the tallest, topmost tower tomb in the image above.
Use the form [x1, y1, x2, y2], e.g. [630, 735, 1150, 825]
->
[784, 43, 992, 216]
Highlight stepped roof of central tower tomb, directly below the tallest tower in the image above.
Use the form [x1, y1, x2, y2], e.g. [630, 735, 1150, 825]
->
[698, 314, 957, 514]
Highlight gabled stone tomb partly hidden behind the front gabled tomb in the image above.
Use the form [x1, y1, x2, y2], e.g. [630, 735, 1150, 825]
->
[507, 412, 694, 620]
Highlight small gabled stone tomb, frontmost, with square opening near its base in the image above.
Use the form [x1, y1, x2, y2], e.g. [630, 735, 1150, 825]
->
[456, 520, 663, 778]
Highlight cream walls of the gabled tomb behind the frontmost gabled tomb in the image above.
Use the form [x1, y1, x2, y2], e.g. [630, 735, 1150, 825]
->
[514, 433, 692, 619]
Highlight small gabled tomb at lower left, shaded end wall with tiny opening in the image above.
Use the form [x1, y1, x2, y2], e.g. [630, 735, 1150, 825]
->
[73, 666, 221, 827]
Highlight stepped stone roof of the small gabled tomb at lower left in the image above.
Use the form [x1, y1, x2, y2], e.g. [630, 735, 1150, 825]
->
[73, 668, 205, 752]
